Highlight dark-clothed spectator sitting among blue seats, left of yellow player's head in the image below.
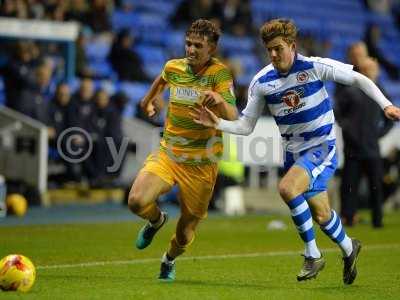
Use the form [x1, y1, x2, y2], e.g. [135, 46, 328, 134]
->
[108, 29, 150, 81]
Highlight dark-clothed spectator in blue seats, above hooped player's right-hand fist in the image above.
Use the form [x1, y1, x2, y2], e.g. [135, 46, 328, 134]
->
[364, 24, 400, 79]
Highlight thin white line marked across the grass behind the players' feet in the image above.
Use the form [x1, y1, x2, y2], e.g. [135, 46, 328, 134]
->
[36, 244, 400, 270]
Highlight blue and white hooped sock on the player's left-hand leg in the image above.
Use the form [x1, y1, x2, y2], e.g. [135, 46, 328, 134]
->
[287, 195, 321, 258]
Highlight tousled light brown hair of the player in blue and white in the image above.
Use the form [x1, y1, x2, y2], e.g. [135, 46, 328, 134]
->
[260, 19, 297, 44]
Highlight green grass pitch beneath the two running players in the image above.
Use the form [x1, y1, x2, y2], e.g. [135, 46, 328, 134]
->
[0, 213, 400, 300]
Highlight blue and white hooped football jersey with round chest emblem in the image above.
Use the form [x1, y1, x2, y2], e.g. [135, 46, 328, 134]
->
[242, 54, 353, 152]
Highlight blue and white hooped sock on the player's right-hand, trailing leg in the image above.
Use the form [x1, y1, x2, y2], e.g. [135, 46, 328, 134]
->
[321, 209, 353, 256]
